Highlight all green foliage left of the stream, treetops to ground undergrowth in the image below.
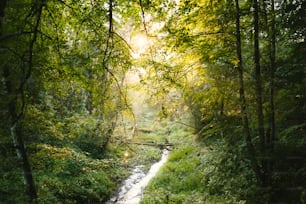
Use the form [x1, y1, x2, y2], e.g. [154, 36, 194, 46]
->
[0, 0, 138, 203]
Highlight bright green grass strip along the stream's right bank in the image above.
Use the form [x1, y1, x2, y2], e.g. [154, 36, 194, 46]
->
[141, 122, 251, 204]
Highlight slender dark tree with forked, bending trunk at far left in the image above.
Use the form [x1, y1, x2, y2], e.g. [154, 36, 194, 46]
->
[0, 0, 44, 203]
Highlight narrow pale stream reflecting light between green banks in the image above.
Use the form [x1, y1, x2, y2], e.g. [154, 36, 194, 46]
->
[106, 149, 169, 204]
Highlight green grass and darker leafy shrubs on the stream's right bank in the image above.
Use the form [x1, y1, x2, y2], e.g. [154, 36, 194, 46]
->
[141, 120, 256, 203]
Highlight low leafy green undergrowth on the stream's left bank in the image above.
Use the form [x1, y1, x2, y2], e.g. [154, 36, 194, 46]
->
[31, 145, 120, 203]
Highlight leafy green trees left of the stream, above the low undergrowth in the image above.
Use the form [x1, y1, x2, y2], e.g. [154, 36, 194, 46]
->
[0, 0, 135, 203]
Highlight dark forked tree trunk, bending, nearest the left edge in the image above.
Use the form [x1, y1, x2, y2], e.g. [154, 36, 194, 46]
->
[0, 0, 42, 204]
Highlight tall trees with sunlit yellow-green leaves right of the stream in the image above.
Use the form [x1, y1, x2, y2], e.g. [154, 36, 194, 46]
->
[139, 0, 305, 202]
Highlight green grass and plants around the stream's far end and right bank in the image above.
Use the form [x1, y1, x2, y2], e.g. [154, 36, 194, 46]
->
[110, 114, 251, 204]
